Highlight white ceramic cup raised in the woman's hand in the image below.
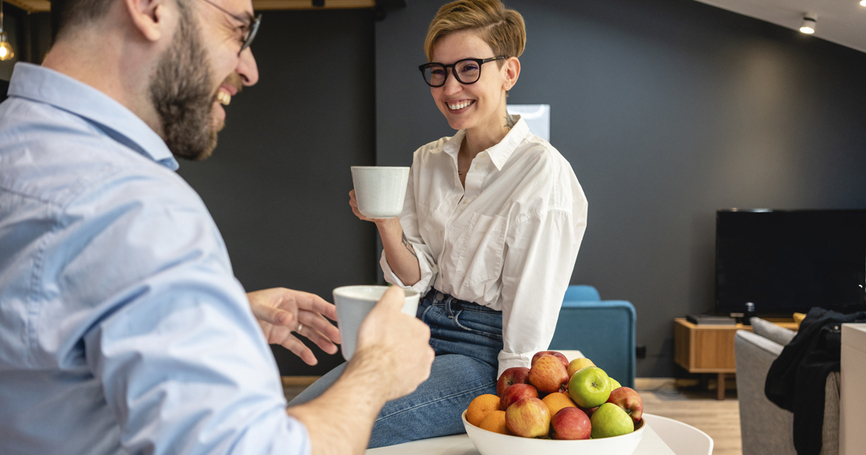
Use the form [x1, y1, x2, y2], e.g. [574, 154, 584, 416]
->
[352, 166, 409, 218]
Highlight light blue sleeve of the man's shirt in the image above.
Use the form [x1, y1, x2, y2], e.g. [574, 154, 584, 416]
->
[61, 171, 310, 454]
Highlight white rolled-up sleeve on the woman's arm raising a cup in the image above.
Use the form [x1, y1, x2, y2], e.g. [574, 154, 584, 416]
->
[379, 160, 439, 296]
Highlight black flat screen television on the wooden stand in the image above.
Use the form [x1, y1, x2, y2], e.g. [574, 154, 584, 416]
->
[715, 209, 866, 318]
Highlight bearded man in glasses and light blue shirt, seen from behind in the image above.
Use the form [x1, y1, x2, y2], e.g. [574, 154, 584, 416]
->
[0, 0, 433, 454]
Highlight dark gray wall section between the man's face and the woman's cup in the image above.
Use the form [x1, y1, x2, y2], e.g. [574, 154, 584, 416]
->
[180, 10, 376, 376]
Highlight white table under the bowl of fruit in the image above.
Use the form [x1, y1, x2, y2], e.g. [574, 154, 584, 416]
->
[365, 414, 712, 455]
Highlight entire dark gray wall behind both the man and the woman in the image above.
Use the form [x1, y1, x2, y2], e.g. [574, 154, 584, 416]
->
[23, 0, 852, 377]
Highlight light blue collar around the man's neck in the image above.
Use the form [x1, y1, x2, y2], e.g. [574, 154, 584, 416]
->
[9, 62, 179, 170]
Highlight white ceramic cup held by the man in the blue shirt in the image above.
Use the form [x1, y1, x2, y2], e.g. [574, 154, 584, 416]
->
[334, 285, 421, 360]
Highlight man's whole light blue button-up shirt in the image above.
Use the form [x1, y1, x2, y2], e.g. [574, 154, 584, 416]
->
[0, 63, 310, 454]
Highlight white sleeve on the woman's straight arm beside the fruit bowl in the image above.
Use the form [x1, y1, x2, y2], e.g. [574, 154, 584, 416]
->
[498, 157, 587, 375]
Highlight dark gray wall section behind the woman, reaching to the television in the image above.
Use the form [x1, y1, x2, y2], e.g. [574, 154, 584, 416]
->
[376, 0, 866, 377]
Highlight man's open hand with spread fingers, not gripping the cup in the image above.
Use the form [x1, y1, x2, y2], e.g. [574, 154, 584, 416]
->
[247, 288, 340, 365]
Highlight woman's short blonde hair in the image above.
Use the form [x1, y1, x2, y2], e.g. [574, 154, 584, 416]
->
[424, 0, 526, 66]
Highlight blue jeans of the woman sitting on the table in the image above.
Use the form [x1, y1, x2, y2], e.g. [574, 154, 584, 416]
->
[289, 289, 502, 448]
